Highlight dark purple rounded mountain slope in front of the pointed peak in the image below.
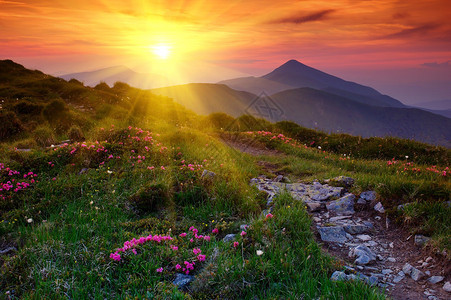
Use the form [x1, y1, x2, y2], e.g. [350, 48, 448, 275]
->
[271, 88, 451, 147]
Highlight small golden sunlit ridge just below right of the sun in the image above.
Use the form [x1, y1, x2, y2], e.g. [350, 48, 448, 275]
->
[150, 83, 257, 117]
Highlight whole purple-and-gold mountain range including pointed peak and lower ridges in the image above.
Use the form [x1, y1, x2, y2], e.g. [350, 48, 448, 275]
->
[152, 60, 451, 147]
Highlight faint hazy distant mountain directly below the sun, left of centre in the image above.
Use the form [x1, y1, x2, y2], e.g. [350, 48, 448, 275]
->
[59, 66, 168, 89]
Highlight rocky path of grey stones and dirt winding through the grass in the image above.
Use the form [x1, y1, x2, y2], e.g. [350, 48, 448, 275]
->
[251, 175, 451, 300]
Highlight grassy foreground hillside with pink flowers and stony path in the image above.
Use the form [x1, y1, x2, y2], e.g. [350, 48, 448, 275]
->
[0, 61, 451, 300]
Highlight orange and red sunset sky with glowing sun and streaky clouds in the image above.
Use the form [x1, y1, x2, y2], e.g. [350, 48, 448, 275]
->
[0, 0, 451, 104]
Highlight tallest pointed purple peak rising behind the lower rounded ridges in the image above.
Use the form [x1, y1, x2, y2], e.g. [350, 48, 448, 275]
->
[219, 60, 405, 107]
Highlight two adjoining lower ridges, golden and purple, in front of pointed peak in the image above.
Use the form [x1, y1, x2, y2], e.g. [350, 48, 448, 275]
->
[151, 83, 451, 147]
